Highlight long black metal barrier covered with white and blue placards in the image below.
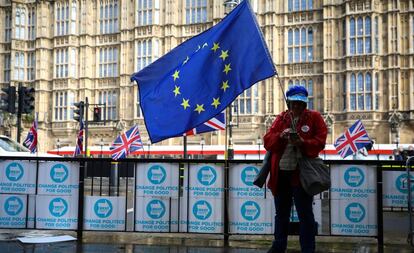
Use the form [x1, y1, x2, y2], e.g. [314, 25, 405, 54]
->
[0, 157, 412, 252]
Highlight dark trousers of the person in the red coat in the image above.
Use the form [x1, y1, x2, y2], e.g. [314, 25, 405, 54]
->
[269, 171, 316, 253]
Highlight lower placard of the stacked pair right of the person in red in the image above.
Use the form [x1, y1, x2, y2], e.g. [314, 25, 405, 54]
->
[331, 199, 377, 236]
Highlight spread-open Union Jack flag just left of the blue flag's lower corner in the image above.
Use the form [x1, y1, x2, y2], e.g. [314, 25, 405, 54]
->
[111, 125, 143, 160]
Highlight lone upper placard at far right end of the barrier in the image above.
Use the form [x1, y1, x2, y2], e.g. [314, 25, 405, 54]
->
[382, 171, 414, 207]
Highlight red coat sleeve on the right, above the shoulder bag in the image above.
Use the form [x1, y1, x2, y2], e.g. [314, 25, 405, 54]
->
[302, 112, 328, 157]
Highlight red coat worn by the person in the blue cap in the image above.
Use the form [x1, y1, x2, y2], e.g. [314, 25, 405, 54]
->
[263, 109, 328, 196]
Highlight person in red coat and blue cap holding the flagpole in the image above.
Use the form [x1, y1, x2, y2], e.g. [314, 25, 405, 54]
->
[264, 86, 327, 253]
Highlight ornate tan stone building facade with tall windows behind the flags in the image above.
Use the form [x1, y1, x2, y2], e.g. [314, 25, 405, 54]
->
[0, 0, 414, 152]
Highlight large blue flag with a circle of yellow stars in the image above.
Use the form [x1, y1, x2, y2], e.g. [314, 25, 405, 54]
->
[131, 1, 276, 143]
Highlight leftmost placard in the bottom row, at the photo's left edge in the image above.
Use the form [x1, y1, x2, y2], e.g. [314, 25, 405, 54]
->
[0, 194, 27, 228]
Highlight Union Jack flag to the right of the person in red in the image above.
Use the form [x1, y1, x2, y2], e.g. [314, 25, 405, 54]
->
[334, 120, 371, 158]
